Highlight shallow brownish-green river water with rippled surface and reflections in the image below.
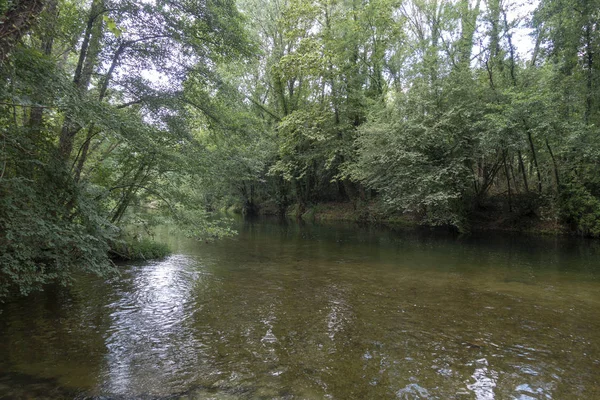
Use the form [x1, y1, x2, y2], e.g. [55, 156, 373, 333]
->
[0, 220, 600, 400]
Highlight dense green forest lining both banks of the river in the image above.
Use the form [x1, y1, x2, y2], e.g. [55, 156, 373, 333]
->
[0, 0, 600, 297]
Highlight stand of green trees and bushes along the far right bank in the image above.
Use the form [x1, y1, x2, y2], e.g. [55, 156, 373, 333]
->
[190, 0, 600, 235]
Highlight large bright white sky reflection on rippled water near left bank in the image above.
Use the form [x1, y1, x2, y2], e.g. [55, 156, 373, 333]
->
[104, 256, 201, 394]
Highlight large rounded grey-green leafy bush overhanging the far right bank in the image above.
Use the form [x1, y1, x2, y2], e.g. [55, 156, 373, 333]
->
[348, 71, 482, 228]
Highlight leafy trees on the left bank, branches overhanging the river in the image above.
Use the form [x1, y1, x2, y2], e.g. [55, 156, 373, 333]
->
[0, 0, 252, 297]
